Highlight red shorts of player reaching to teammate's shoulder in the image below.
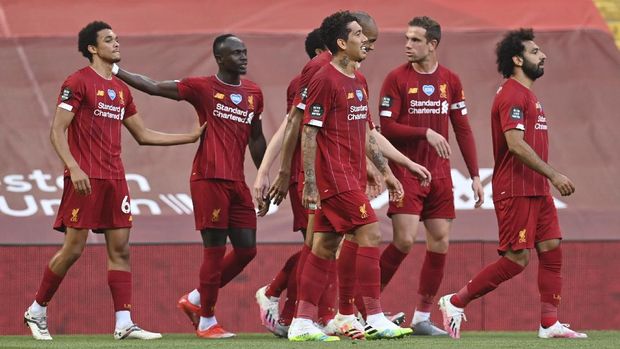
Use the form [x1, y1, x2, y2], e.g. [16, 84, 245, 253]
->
[189, 179, 256, 230]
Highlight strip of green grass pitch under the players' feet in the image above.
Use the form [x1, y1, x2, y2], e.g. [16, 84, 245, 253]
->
[0, 331, 620, 349]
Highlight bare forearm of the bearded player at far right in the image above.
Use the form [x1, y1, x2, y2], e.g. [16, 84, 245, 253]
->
[504, 129, 575, 196]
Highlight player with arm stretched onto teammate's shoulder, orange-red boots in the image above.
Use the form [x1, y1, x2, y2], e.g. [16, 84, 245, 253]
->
[118, 34, 266, 338]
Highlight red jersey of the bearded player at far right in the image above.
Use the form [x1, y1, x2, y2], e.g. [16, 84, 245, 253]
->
[491, 79, 551, 201]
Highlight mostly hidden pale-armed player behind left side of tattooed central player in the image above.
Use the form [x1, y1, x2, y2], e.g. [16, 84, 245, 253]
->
[254, 28, 336, 337]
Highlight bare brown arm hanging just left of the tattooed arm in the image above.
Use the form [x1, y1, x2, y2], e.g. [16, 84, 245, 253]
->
[269, 106, 304, 205]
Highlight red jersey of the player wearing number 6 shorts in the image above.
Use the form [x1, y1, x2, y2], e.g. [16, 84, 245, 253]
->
[58, 67, 137, 179]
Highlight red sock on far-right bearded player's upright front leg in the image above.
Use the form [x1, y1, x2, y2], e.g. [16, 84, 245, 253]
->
[538, 246, 562, 328]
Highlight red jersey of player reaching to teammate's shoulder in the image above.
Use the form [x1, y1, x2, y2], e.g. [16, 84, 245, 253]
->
[177, 76, 263, 181]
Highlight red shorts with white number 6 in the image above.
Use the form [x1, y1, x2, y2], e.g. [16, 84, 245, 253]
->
[54, 177, 132, 233]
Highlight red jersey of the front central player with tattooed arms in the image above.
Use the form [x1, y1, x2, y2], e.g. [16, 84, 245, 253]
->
[304, 64, 370, 199]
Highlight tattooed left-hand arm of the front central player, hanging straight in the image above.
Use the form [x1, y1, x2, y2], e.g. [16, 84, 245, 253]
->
[301, 125, 321, 210]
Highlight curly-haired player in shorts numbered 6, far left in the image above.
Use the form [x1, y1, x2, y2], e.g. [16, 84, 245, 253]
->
[24, 21, 203, 340]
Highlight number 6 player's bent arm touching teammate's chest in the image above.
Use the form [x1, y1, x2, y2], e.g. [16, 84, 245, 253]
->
[123, 114, 207, 145]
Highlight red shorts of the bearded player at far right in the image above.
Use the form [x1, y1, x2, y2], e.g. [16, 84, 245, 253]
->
[494, 196, 562, 254]
